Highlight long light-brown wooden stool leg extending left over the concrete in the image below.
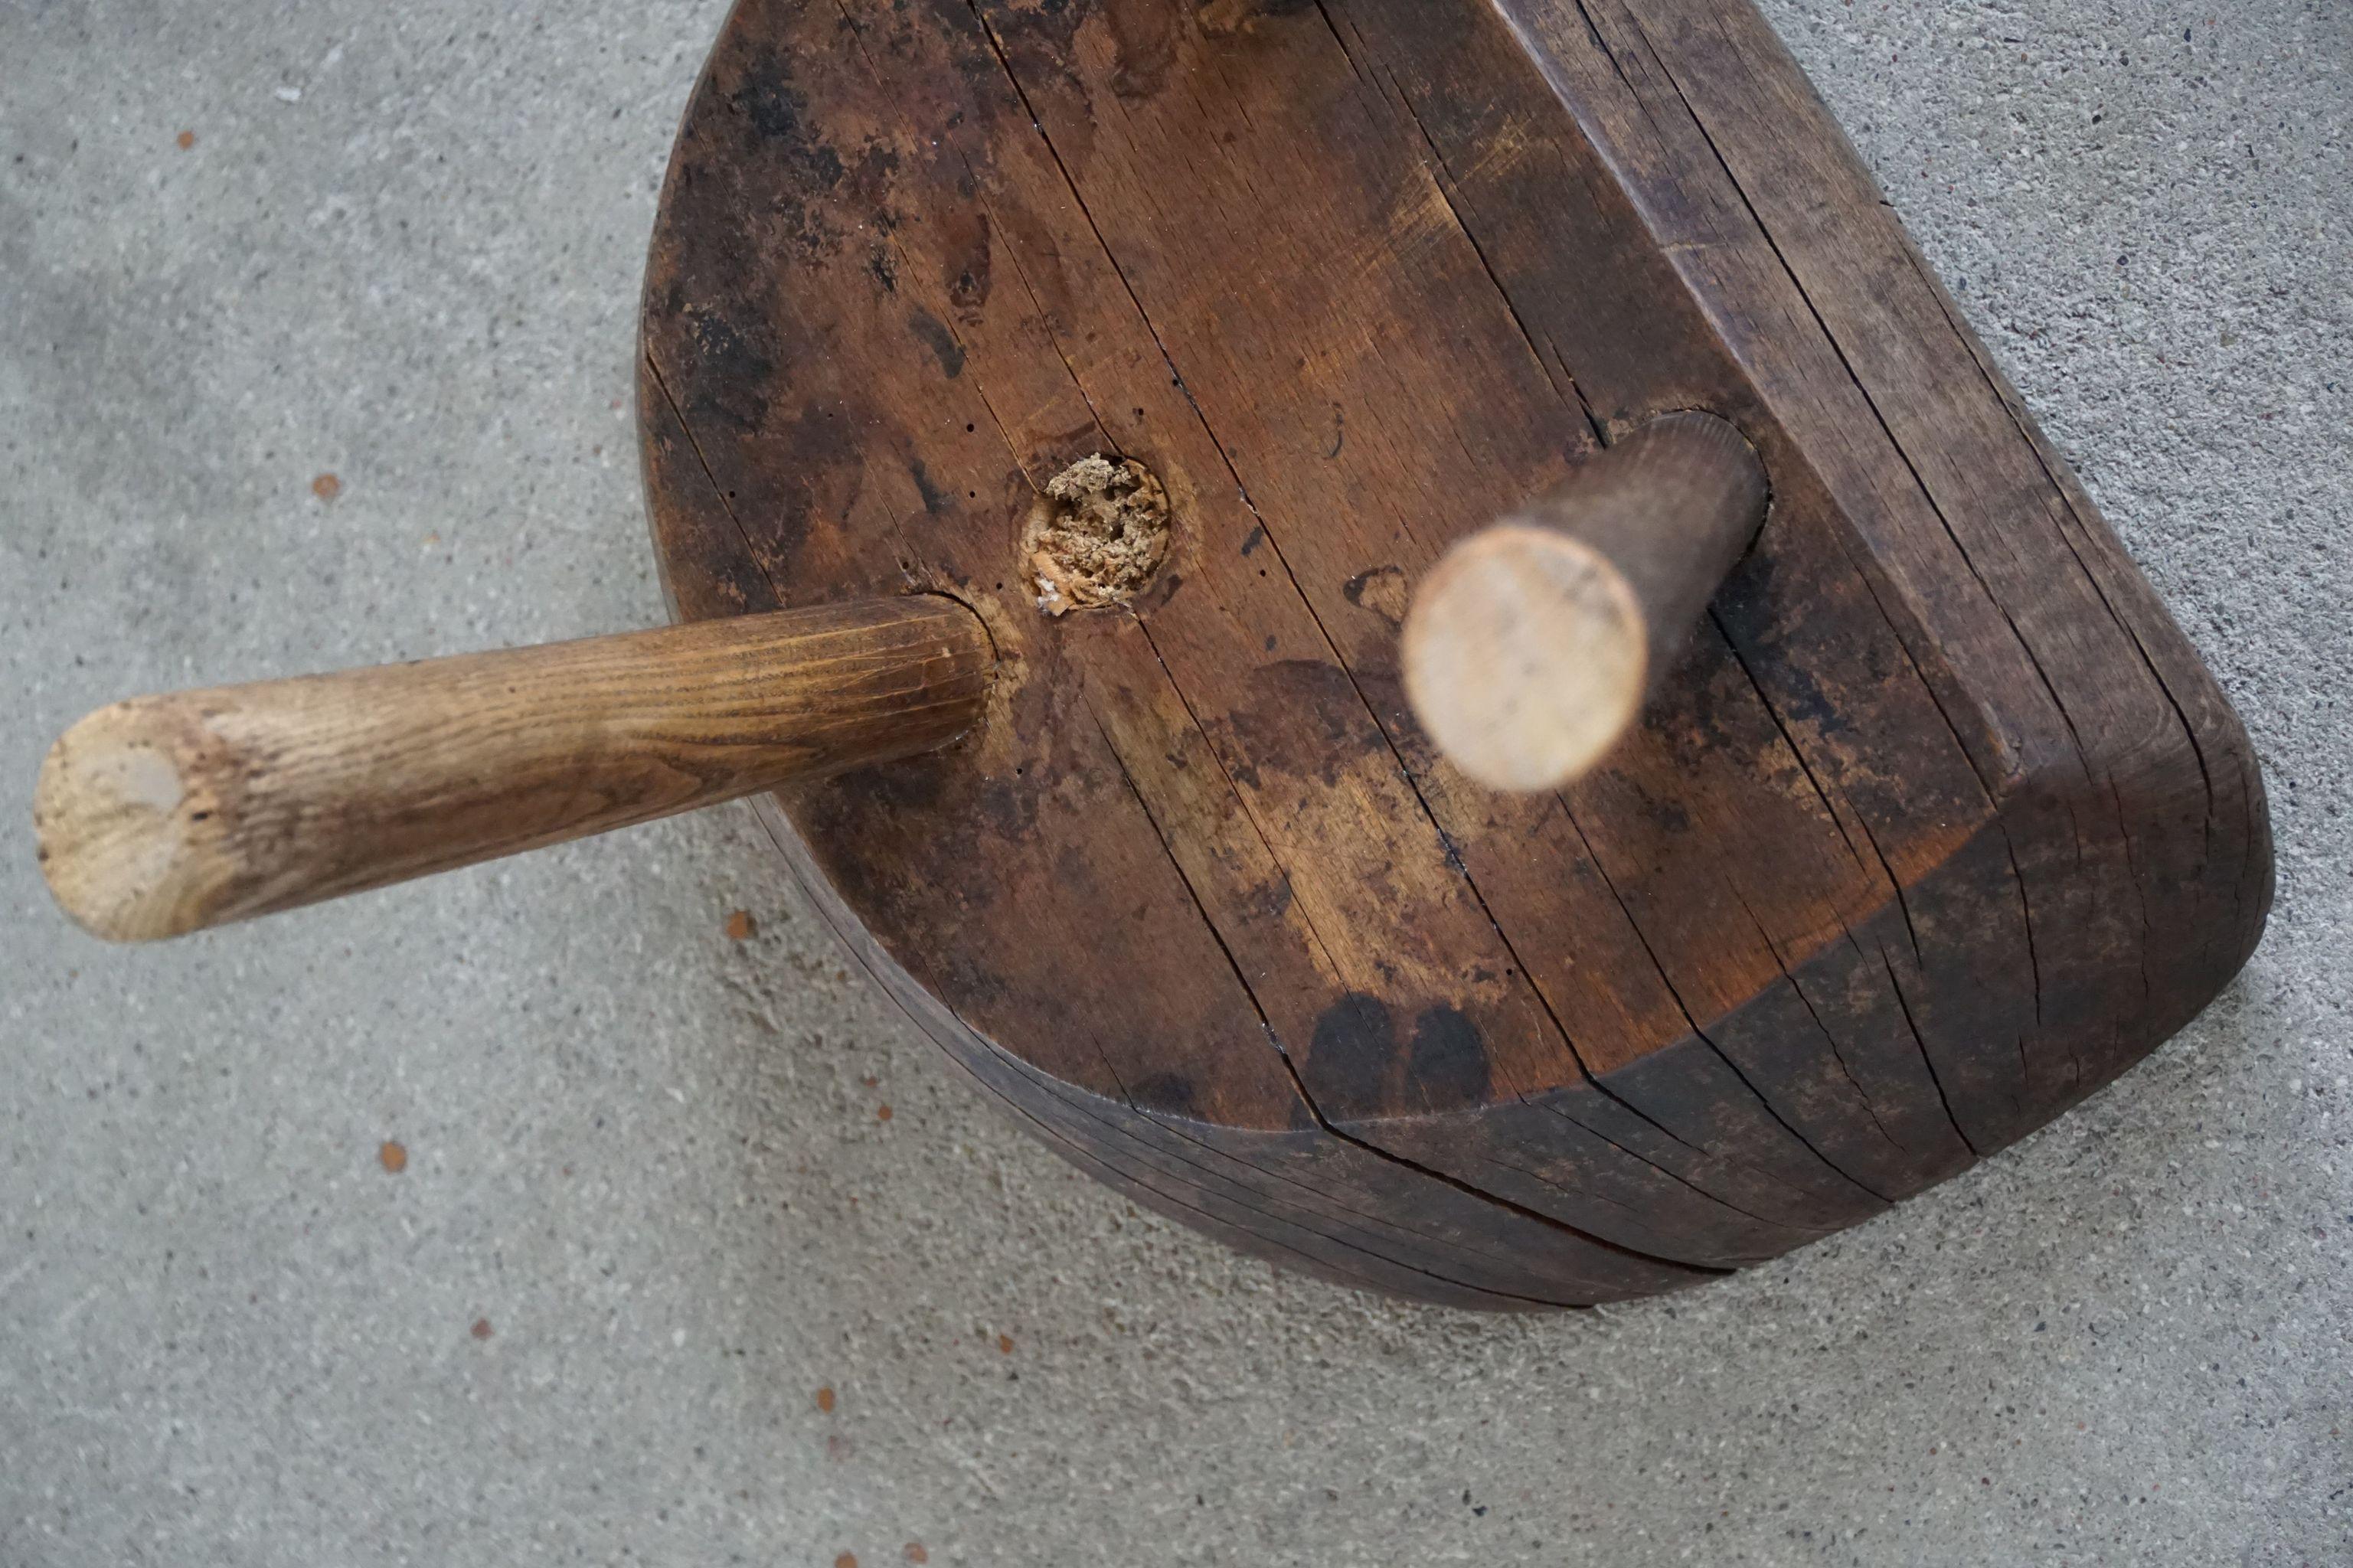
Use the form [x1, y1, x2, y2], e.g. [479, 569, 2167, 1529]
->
[33, 596, 995, 942]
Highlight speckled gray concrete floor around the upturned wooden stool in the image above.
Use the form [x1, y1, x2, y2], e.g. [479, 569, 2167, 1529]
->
[0, 0, 2353, 1568]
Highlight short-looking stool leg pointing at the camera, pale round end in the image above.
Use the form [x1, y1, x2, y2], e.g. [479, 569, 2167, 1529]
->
[1403, 412, 1770, 791]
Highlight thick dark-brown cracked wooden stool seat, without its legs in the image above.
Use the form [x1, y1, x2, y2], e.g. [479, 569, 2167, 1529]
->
[640, 0, 2270, 1307]
